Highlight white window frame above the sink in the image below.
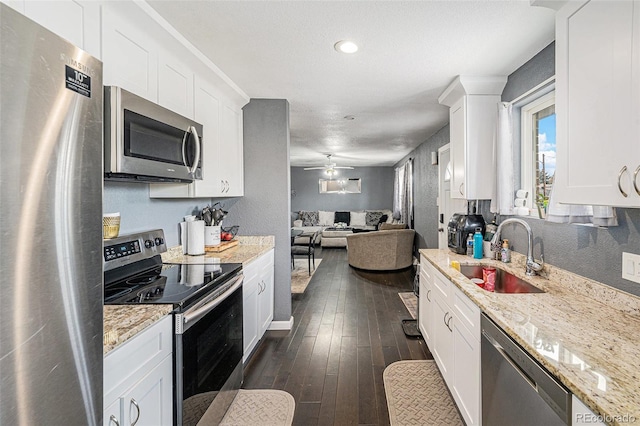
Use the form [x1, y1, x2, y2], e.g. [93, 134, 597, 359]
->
[520, 90, 556, 218]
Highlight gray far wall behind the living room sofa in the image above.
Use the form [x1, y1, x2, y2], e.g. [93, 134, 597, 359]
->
[291, 167, 395, 212]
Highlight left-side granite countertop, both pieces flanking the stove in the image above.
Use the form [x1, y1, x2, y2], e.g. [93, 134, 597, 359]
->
[103, 236, 275, 355]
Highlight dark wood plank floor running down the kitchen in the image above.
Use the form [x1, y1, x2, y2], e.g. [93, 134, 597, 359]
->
[244, 249, 433, 425]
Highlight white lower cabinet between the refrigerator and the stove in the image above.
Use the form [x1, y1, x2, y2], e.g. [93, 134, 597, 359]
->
[103, 315, 173, 426]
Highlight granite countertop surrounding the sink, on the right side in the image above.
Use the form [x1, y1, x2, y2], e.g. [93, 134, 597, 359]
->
[420, 249, 640, 425]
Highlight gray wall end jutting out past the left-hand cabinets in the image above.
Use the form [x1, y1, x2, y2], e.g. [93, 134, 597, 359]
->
[225, 99, 291, 321]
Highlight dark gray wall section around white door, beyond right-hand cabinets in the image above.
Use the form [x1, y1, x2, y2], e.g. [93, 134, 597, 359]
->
[396, 124, 449, 249]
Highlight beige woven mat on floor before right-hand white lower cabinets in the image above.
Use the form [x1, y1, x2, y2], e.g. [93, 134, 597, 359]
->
[382, 360, 463, 426]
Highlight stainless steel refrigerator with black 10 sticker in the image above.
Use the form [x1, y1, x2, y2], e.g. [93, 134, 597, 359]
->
[0, 4, 103, 426]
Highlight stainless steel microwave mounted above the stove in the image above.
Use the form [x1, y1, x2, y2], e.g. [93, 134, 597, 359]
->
[104, 86, 202, 183]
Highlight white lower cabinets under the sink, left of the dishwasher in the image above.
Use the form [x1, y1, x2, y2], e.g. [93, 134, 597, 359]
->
[419, 257, 482, 425]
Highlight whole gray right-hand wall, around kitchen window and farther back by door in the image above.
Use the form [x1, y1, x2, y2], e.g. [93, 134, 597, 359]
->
[398, 43, 640, 295]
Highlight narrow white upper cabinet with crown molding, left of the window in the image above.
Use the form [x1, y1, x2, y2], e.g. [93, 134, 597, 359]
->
[438, 76, 507, 200]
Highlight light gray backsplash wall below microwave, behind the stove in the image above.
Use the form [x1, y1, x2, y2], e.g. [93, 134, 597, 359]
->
[102, 181, 211, 247]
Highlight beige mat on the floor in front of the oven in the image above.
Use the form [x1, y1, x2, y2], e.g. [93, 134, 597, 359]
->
[220, 389, 296, 426]
